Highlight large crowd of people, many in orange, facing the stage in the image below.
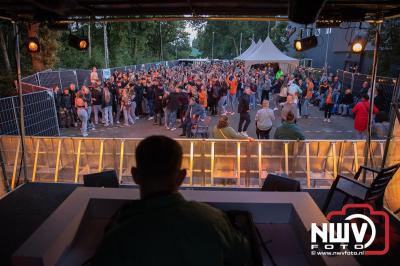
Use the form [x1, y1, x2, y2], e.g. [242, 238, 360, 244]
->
[54, 63, 389, 140]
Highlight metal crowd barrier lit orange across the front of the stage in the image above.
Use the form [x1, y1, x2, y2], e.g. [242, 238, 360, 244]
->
[0, 136, 394, 188]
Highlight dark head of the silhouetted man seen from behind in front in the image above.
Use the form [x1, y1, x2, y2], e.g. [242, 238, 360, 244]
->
[132, 136, 186, 198]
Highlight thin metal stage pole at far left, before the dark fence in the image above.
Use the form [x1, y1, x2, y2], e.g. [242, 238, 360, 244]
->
[13, 22, 28, 185]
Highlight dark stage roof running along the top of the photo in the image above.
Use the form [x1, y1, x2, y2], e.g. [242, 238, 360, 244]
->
[0, 0, 400, 20]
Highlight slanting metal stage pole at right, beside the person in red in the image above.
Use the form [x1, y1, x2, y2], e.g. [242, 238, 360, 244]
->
[362, 23, 381, 183]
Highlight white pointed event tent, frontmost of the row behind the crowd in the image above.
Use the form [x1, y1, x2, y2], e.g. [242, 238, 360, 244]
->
[239, 36, 299, 73]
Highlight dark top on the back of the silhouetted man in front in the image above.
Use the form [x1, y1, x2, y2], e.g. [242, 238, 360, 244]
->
[92, 193, 251, 266]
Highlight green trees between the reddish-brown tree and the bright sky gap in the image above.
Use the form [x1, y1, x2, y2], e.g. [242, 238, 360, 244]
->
[58, 21, 191, 69]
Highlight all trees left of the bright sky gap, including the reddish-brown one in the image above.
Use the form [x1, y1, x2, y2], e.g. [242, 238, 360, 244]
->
[0, 21, 191, 95]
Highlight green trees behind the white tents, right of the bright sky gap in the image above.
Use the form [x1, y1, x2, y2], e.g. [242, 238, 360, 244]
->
[191, 21, 289, 59]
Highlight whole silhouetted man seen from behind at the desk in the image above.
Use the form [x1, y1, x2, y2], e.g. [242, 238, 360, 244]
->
[93, 136, 251, 266]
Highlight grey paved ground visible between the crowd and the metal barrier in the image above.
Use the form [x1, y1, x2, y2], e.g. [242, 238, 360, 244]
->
[61, 103, 356, 139]
